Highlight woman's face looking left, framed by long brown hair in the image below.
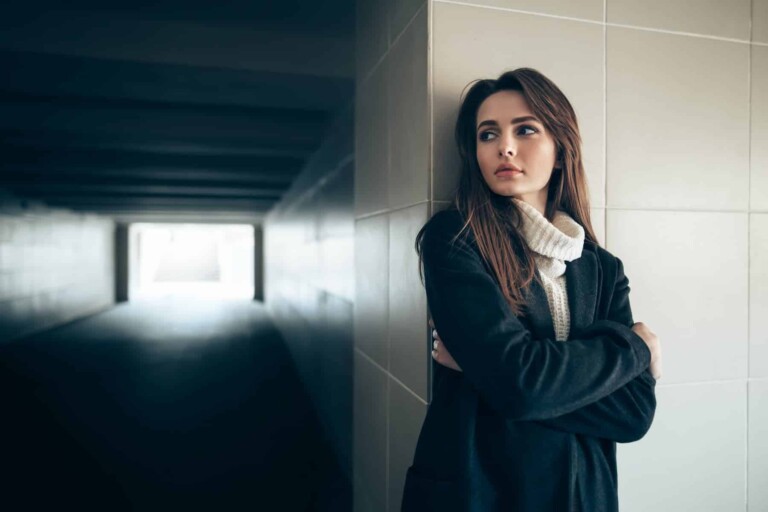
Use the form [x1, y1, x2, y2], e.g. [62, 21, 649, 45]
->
[476, 91, 556, 213]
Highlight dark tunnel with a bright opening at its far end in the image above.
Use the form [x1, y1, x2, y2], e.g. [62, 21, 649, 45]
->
[0, 0, 355, 511]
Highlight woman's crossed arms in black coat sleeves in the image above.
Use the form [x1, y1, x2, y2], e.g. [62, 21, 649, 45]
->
[423, 214, 656, 442]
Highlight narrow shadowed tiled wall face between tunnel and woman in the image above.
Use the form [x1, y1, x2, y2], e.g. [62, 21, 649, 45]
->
[354, 0, 431, 512]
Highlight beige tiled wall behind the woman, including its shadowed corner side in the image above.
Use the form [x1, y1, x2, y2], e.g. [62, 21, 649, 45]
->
[356, 0, 768, 512]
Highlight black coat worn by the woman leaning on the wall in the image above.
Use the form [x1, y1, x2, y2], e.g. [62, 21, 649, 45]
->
[402, 210, 656, 512]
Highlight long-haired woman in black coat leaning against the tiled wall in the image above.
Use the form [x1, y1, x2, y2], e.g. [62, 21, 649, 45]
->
[402, 68, 661, 512]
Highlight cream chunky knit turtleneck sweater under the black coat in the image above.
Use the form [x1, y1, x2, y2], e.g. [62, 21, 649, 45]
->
[512, 198, 584, 341]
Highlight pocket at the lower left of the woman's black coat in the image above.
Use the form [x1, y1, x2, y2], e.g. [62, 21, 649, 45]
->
[401, 466, 464, 512]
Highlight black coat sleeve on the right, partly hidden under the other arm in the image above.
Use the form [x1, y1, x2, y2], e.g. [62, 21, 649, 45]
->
[541, 258, 656, 443]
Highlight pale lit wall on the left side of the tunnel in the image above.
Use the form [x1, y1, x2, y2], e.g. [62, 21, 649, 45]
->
[0, 191, 115, 342]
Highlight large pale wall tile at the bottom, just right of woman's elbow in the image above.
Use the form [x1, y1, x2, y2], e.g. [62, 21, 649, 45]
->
[617, 381, 747, 512]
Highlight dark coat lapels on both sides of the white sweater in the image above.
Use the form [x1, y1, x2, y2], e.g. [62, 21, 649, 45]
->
[526, 242, 602, 340]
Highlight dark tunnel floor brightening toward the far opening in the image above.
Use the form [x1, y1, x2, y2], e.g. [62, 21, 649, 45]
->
[0, 299, 349, 511]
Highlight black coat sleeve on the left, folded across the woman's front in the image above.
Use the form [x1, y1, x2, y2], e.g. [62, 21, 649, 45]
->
[422, 212, 650, 420]
